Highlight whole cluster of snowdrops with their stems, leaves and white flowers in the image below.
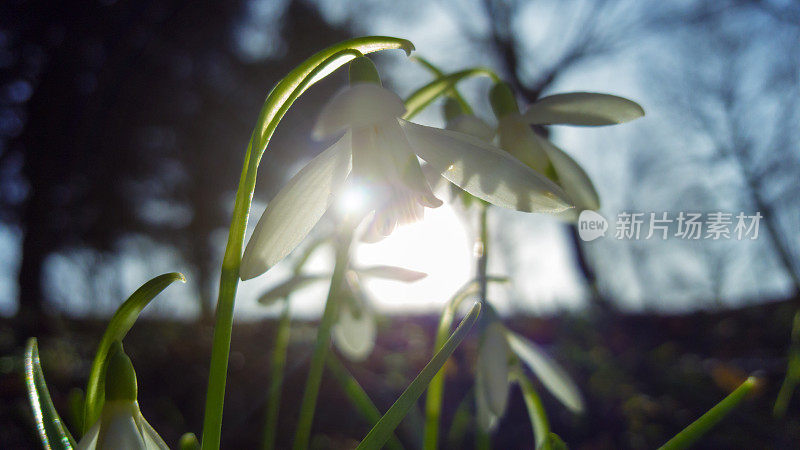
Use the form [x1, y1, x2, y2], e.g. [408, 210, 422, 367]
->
[26, 37, 755, 449]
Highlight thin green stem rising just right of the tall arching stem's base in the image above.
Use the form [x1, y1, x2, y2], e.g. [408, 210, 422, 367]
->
[261, 299, 291, 450]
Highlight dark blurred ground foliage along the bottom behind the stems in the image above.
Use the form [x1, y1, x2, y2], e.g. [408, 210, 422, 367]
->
[0, 302, 800, 449]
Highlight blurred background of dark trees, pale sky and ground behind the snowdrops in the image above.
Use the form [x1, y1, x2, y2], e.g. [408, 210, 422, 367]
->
[0, 0, 800, 448]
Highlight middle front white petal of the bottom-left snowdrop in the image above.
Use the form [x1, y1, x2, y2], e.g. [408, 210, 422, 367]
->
[97, 401, 146, 450]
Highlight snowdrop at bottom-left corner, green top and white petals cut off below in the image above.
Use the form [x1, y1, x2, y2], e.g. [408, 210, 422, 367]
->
[77, 342, 169, 450]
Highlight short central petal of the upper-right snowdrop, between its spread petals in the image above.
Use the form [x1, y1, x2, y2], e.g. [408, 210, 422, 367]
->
[497, 114, 550, 174]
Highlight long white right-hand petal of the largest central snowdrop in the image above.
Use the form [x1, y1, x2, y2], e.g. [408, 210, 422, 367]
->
[400, 120, 571, 212]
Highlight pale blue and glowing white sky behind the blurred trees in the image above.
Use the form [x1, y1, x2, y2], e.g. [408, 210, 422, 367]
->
[0, 0, 800, 319]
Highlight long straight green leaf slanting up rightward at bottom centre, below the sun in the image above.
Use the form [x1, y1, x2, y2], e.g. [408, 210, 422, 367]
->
[357, 303, 481, 450]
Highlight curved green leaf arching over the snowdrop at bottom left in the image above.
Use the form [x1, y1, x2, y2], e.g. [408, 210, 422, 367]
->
[83, 272, 186, 433]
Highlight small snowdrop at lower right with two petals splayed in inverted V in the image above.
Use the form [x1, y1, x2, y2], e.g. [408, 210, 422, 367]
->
[475, 318, 583, 431]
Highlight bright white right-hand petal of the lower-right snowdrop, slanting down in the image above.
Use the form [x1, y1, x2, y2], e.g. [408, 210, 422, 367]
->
[507, 332, 583, 412]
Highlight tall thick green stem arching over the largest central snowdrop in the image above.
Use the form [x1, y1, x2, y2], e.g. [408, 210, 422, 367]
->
[202, 36, 414, 450]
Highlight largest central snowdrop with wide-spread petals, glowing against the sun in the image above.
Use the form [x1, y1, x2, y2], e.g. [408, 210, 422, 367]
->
[240, 58, 572, 280]
